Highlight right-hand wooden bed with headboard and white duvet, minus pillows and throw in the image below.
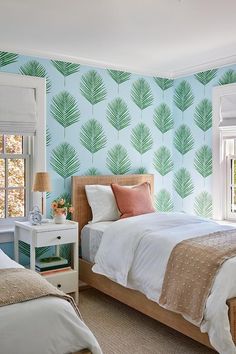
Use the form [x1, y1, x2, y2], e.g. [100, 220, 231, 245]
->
[72, 175, 236, 354]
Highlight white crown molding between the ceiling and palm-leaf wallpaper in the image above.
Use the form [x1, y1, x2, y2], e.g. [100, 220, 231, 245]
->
[1, 46, 236, 79]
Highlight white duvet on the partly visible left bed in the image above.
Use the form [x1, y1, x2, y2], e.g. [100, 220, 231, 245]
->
[0, 250, 102, 354]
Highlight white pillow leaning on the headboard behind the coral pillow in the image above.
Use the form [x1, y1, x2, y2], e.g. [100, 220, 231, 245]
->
[85, 184, 120, 223]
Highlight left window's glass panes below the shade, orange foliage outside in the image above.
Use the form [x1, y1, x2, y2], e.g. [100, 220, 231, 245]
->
[0, 135, 31, 220]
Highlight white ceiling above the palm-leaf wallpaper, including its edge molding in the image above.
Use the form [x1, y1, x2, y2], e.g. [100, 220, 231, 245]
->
[0, 0, 236, 77]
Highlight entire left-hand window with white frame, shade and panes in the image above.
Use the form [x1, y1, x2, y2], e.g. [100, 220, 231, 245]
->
[0, 73, 46, 231]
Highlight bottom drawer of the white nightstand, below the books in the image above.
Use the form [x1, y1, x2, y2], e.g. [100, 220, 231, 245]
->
[45, 270, 78, 293]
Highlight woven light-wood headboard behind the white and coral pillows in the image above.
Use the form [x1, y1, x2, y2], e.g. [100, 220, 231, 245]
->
[71, 174, 154, 232]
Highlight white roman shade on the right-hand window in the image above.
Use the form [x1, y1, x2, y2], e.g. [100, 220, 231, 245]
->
[219, 94, 236, 129]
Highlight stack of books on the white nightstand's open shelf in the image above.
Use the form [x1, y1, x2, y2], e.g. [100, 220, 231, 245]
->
[35, 256, 71, 275]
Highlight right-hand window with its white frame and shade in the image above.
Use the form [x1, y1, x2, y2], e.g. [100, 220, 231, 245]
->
[212, 84, 236, 220]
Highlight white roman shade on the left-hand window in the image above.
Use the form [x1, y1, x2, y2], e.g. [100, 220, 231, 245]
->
[0, 85, 37, 135]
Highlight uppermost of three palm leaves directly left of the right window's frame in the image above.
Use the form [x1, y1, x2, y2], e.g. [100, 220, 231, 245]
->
[194, 98, 212, 132]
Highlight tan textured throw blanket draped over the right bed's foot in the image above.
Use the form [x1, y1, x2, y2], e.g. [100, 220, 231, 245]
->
[159, 229, 236, 326]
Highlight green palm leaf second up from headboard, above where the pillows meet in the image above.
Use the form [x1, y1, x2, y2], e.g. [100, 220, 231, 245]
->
[107, 97, 131, 138]
